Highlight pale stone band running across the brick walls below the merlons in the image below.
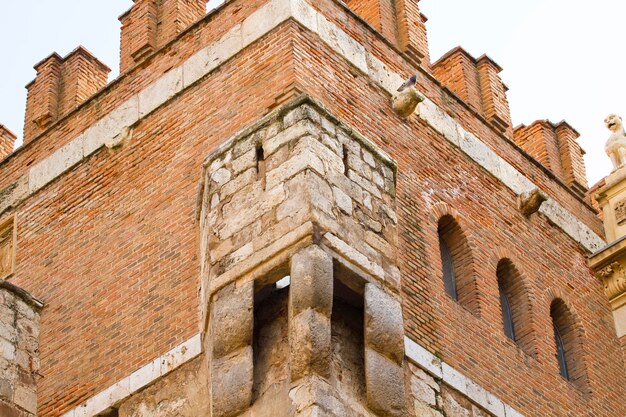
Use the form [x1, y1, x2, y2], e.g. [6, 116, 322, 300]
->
[0, 0, 605, 253]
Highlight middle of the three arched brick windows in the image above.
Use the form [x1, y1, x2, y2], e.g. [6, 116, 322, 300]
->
[496, 258, 537, 356]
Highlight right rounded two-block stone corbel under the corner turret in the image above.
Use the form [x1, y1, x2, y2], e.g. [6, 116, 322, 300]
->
[364, 283, 406, 416]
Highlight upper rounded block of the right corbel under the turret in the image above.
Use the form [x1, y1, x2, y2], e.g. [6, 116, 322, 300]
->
[365, 284, 404, 365]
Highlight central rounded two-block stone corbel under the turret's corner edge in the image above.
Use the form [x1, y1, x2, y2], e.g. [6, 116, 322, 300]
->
[289, 245, 333, 381]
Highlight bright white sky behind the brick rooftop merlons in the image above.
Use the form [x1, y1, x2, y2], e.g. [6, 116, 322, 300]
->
[0, 0, 626, 185]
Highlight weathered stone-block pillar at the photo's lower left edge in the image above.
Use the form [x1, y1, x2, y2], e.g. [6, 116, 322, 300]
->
[0, 280, 43, 417]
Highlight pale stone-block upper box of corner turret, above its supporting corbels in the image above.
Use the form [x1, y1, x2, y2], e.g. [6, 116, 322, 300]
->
[201, 97, 400, 317]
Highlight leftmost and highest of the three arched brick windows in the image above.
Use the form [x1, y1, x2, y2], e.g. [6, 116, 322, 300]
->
[437, 215, 478, 313]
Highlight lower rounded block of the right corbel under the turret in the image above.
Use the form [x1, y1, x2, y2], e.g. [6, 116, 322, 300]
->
[365, 347, 406, 417]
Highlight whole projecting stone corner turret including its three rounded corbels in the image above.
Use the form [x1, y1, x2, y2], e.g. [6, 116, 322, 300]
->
[201, 99, 406, 417]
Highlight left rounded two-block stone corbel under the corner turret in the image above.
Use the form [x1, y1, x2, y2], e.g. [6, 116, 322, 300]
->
[209, 282, 254, 417]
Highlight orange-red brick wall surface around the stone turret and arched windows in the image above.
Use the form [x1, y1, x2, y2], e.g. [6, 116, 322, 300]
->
[0, 0, 624, 416]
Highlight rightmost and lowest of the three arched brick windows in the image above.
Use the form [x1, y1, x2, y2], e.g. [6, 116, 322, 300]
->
[550, 298, 588, 389]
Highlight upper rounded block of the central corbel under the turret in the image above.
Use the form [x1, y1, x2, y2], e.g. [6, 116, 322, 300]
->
[289, 245, 333, 317]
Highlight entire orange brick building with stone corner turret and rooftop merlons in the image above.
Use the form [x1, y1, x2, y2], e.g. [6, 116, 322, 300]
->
[0, 0, 626, 417]
